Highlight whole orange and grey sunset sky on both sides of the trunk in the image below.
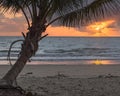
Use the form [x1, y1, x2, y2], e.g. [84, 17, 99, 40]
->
[0, 10, 120, 37]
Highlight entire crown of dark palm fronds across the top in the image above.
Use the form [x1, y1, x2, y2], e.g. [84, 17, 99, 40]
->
[0, 0, 120, 26]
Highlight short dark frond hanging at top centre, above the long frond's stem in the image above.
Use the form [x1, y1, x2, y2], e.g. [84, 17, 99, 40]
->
[48, 0, 84, 20]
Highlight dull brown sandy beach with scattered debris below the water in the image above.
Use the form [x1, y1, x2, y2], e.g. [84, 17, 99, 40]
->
[0, 65, 120, 96]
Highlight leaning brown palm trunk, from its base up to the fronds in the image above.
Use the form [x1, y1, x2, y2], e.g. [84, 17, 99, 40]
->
[0, 23, 45, 86]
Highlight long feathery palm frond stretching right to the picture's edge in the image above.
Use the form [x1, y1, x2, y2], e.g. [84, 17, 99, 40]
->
[51, 0, 120, 26]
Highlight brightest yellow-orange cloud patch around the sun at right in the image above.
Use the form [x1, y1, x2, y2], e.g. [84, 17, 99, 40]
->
[87, 20, 117, 36]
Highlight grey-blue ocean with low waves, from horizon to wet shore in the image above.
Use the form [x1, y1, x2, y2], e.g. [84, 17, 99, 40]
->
[0, 36, 120, 64]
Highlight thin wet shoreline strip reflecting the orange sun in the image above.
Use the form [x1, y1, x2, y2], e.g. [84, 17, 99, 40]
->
[0, 59, 120, 65]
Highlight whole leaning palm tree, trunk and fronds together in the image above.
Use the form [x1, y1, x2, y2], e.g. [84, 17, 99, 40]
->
[0, 0, 120, 86]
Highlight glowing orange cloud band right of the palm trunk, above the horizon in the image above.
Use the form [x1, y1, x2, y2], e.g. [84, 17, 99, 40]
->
[46, 20, 120, 37]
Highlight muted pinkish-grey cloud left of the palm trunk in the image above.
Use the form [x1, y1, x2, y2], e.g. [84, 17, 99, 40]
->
[0, 14, 27, 33]
